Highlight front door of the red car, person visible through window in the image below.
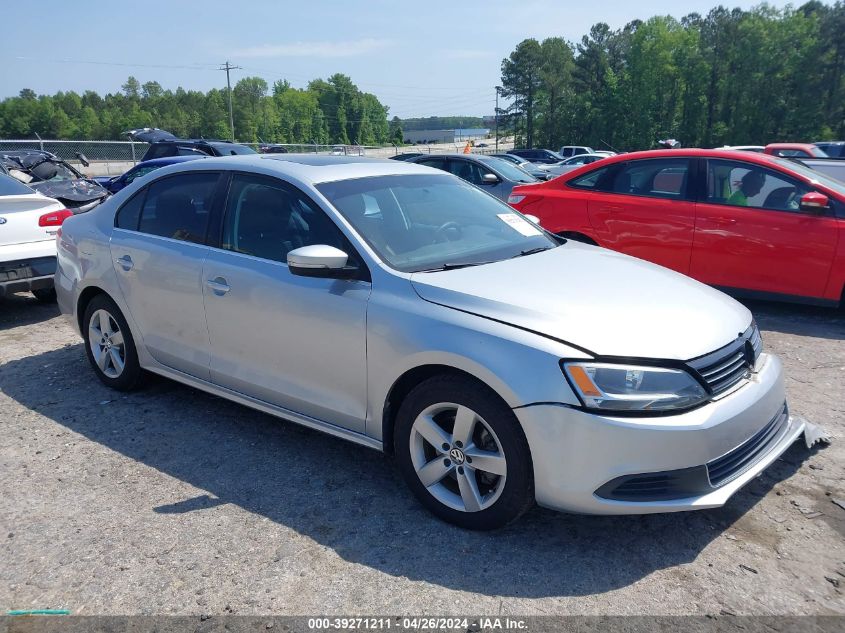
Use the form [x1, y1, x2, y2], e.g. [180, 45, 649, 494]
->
[690, 159, 839, 297]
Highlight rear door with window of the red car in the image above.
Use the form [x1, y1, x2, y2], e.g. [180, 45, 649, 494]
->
[588, 158, 695, 274]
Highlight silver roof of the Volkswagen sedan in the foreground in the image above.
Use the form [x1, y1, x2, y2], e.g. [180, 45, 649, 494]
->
[157, 154, 436, 185]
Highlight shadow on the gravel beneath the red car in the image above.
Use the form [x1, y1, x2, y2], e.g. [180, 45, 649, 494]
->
[742, 300, 845, 340]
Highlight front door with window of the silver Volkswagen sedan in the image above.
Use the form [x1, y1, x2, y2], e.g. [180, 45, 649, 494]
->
[202, 174, 371, 432]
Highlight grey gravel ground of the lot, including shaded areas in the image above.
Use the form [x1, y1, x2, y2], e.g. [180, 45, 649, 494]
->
[0, 295, 845, 615]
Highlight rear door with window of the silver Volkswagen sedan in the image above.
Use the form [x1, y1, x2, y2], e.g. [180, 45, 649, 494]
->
[111, 172, 220, 380]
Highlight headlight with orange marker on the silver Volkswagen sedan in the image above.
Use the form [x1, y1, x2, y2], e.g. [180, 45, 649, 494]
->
[563, 361, 708, 412]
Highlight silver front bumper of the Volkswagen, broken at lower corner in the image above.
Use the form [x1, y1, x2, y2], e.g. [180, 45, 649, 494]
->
[514, 354, 804, 514]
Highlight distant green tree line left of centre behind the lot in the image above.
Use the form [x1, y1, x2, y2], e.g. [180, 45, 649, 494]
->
[0, 73, 402, 145]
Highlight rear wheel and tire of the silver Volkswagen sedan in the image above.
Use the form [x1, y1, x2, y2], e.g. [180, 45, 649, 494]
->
[82, 295, 141, 391]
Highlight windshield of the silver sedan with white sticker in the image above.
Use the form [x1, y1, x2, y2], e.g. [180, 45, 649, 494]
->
[317, 174, 559, 272]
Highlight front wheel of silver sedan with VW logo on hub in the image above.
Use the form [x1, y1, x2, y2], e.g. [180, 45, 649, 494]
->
[394, 376, 534, 530]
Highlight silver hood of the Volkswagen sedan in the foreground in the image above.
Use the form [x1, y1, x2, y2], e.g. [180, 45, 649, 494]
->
[411, 241, 751, 360]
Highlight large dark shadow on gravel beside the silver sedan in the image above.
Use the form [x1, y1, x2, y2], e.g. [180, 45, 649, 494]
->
[0, 344, 809, 597]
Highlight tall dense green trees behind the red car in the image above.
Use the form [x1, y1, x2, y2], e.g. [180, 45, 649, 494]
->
[500, 0, 845, 150]
